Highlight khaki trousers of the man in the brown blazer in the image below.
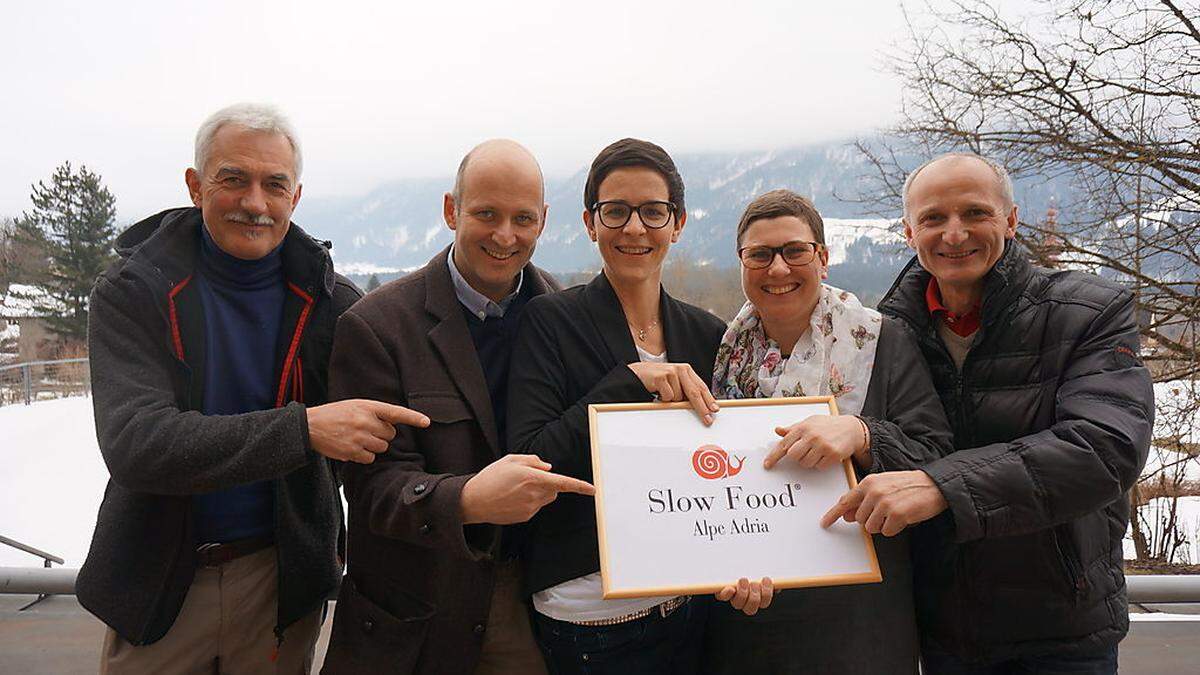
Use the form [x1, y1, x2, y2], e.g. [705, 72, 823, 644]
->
[475, 562, 546, 675]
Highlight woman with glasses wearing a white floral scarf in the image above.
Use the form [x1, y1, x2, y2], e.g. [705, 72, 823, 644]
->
[704, 190, 952, 675]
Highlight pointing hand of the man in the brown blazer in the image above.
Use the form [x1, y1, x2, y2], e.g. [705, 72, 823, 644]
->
[462, 455, 595, 525]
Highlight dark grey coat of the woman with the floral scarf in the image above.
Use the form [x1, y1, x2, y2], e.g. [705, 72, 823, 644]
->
[703, 317, 954, 675]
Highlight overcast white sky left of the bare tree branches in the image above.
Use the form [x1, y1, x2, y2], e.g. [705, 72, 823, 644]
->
[0, 0, 902, 222]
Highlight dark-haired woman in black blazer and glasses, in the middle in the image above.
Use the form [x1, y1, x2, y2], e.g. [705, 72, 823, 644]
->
[509, 138, 725, 675]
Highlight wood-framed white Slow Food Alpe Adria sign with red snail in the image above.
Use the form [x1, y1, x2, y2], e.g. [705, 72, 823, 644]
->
[588, 396, 882, 598]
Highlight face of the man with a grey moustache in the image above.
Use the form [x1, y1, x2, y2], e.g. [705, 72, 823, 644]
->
[185, 124, 300, 261]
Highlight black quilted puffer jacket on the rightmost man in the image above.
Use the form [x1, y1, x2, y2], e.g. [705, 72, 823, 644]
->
[880, 243, 1154, 662]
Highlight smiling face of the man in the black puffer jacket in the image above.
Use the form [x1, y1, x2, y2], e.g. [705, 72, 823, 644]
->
[904, 157, 1016, 300]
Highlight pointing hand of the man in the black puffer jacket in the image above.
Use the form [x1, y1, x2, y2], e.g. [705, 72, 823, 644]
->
[821, 471, 947, 537]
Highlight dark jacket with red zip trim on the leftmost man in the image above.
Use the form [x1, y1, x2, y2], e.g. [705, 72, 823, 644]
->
[76, 209, 360, 645]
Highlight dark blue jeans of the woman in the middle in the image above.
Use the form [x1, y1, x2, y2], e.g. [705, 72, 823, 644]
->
[533, 597, 709, 675]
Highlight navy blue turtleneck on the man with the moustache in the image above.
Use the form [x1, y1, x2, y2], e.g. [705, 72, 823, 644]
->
[192, 227, 286, 543]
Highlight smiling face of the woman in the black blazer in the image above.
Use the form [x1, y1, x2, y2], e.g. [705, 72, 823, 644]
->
[583, 167, 688, 285]
